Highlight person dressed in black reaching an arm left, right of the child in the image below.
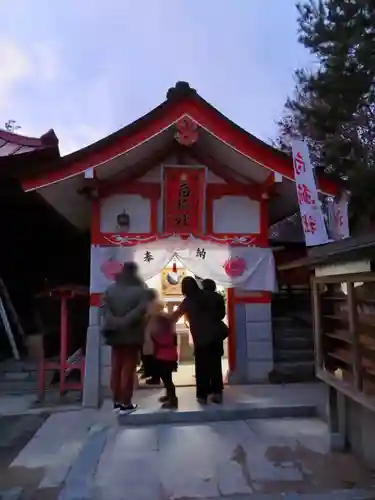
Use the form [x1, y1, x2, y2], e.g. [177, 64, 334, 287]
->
[172, 276, 225, 404]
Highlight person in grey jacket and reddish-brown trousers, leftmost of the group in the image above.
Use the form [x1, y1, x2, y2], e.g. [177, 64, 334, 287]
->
[102, 262, 150, 413]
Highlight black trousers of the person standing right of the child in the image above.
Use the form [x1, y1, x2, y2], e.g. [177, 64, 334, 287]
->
[195, 341, 224, 399]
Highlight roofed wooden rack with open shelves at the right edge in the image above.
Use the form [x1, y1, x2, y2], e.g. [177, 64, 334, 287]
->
[285, 233, 375, 467]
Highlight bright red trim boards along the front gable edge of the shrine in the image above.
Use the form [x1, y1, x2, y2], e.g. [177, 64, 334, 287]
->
[23, 97, 338, 195]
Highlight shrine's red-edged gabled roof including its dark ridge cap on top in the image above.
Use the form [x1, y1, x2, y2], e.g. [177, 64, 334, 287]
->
[22, 82, 338, 194]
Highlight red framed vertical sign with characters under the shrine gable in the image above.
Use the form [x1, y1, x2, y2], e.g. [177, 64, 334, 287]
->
[164, 167, 205, 234]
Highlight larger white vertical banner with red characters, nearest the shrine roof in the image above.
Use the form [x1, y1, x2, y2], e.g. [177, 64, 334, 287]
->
[292, 140, 329, 247]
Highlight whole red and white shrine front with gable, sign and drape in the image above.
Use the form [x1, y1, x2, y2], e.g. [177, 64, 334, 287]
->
[19, 82, 336, 406]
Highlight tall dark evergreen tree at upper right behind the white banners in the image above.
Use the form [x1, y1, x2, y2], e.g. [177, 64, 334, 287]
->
[277, 0, 375, 227]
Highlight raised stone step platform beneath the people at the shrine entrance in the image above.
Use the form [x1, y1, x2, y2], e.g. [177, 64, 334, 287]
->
[118, 384, 325, 426]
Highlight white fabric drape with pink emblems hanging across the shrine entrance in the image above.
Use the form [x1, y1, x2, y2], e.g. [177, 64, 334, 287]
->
[91, 237, 276, 293]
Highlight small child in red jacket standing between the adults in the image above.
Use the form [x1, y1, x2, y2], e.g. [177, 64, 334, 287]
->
[150, 302, 178, 409]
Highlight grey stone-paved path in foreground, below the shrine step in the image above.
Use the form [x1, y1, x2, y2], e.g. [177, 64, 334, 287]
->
[59, 419, 375, 500]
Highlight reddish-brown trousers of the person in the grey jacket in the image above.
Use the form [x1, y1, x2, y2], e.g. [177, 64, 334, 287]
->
[111, 346, 139, 405]
